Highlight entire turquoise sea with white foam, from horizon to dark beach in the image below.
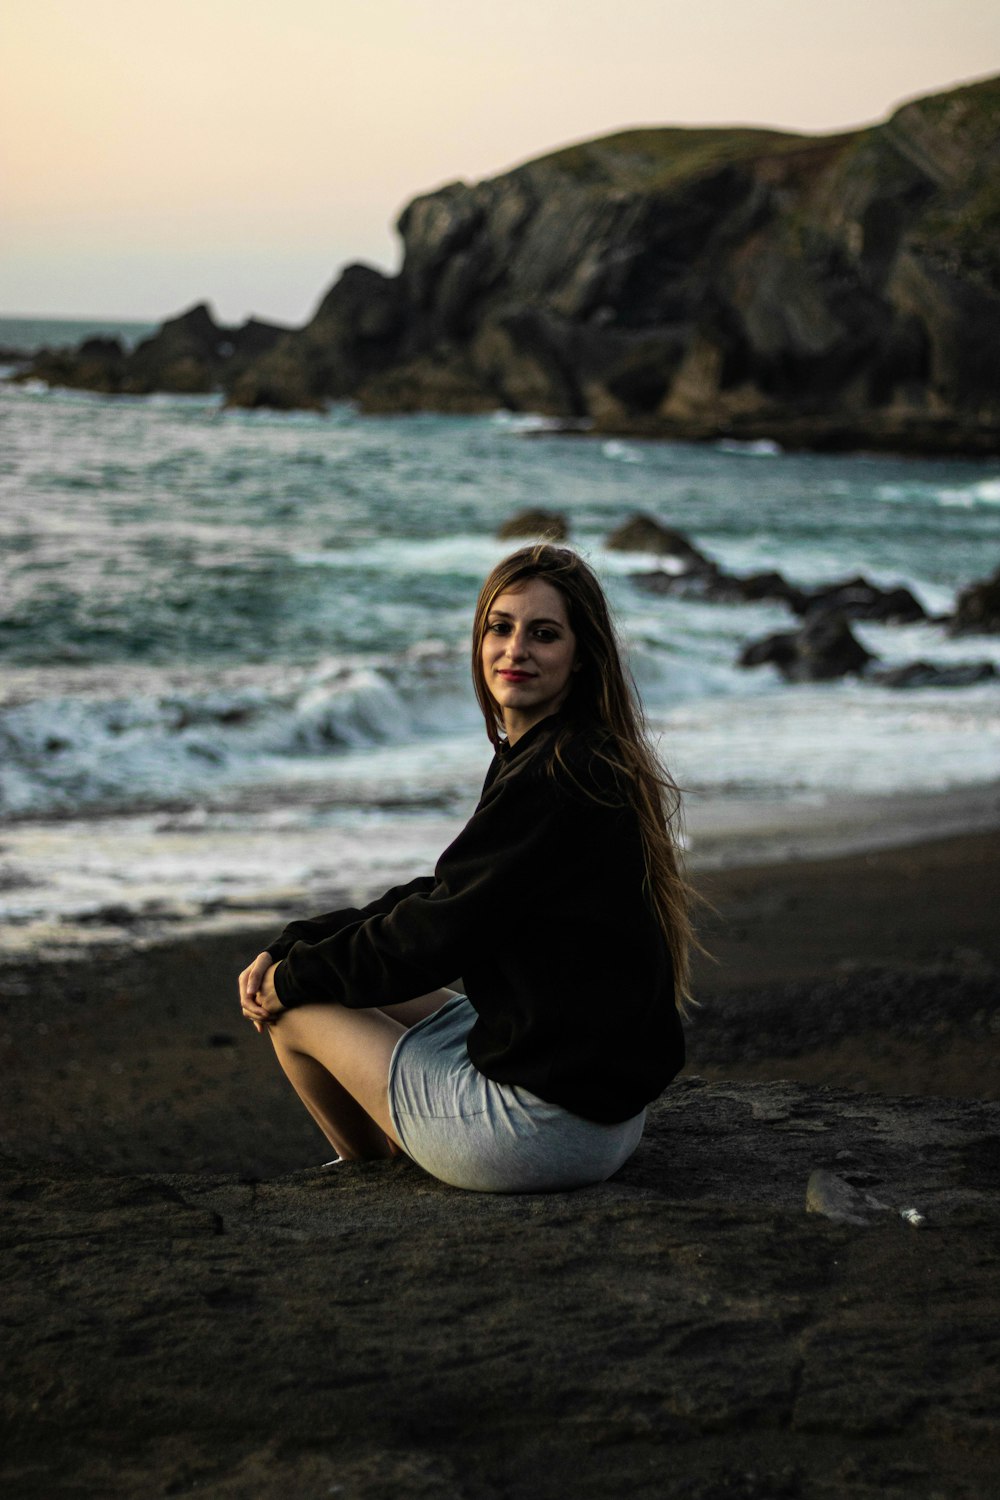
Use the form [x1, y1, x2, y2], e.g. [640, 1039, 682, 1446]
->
[0, 320, 1000, 947]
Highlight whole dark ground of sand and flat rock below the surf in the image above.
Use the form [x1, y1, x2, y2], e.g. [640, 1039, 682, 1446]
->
[0, 834, 1000, 1500]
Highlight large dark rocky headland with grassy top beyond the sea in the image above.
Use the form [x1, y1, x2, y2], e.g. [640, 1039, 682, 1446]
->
[15, 78, 1000, 455]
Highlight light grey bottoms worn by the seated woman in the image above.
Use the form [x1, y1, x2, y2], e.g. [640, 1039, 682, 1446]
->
[388, 995, 646, 1193]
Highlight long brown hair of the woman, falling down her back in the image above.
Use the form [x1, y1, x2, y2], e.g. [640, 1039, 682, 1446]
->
[472, 543, 696, 1011]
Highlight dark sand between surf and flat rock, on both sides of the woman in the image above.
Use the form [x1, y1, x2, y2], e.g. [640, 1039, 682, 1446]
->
[0, 833, 1000, 1176]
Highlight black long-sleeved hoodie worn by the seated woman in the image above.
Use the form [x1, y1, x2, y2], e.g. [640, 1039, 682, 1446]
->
[268, 719, 684, 1124]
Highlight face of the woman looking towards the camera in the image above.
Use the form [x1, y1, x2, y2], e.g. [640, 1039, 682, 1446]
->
[481, 578, 577, 744]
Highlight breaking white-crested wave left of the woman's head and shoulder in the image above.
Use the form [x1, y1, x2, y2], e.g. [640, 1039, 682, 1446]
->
[0, 642, 471, 816]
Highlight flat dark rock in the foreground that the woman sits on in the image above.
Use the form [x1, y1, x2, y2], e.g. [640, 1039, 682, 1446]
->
[0, 1079, 1000, 1500]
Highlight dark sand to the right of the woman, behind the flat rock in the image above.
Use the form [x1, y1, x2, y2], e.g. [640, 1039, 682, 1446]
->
[688, 831, 1000, 1098]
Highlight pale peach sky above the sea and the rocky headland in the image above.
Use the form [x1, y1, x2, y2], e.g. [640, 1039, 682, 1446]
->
[0, 0, 1000, 323]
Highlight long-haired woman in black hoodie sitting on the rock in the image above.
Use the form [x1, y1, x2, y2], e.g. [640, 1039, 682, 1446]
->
[240, 546, 691, 1193]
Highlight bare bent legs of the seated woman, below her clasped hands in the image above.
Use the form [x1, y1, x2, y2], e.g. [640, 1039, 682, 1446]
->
[268, 990, 454, 1161]
